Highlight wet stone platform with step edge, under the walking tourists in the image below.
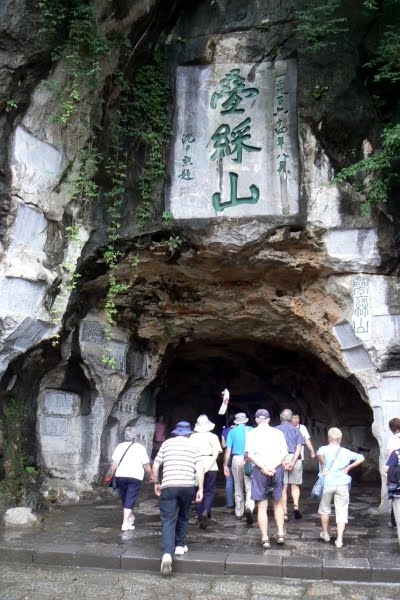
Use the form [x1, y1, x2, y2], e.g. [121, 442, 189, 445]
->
[0, 484, 400, 584]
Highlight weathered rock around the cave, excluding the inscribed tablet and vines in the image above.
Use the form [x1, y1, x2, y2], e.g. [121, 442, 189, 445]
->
[0, 0, 400, 500]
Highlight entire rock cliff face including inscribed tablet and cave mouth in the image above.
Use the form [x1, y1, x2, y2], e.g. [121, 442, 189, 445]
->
[0, 0, 400, 500]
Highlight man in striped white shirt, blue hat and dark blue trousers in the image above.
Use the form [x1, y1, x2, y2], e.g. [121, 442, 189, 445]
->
[153, 421, 204, 576]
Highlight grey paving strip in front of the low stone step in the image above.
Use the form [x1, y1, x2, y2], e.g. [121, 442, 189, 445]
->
[0, 563, 400, 600]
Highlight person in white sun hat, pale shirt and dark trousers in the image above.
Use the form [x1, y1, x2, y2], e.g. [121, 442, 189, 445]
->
[190, 415, 222, 529]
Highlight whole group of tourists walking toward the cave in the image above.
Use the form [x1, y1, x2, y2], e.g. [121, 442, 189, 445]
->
[106, 408, 400, 576]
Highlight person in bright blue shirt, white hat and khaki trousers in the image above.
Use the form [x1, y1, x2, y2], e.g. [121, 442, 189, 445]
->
[224, 413, 255, 525]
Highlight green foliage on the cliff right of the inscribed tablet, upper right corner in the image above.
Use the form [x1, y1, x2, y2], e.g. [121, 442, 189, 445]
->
[296, 0, 400, 213]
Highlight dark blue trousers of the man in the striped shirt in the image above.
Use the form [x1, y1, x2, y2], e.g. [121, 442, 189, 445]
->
[160, 487, 195, 556]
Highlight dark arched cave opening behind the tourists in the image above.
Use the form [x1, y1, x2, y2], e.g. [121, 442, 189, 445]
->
[152, 339, 380, 482]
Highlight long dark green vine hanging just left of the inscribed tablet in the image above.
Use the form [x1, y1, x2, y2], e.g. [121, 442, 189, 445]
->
[102, 51, 173, 369]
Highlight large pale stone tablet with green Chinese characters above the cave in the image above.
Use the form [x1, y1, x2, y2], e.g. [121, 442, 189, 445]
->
[167, 59, 299, 219]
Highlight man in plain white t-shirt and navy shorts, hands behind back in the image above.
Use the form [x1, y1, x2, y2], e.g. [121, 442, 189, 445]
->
[246, 408, 288, 548]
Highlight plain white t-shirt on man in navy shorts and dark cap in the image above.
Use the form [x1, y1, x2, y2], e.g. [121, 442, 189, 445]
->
[246, 423, 288, 469]
